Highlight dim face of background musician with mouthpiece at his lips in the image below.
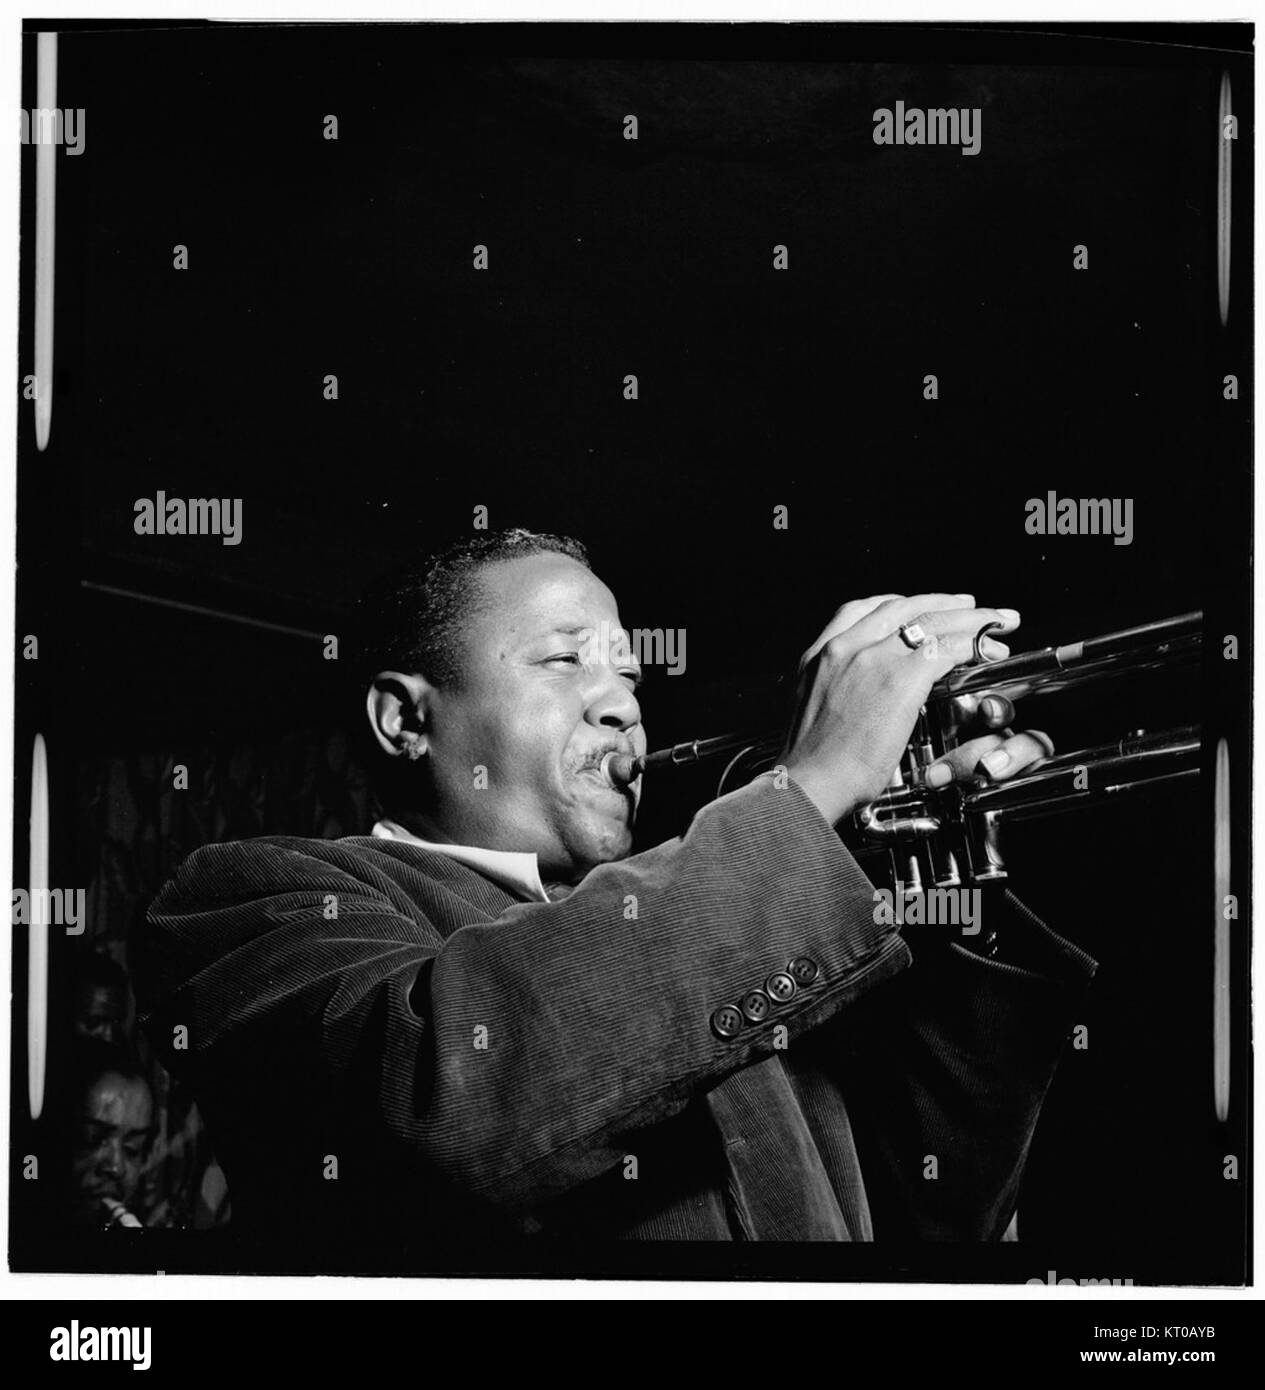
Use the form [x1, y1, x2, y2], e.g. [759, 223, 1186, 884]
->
[71, 1072, 153, 1220]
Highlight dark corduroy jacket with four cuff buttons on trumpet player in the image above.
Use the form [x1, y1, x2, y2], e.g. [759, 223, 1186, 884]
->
[142, 776, 1094, 1257]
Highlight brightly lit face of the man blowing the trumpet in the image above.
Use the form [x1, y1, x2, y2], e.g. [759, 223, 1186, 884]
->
[371, 552, 646, 883]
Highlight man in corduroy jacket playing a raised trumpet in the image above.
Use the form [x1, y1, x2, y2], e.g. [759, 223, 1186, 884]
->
[136, 531, 1094, 1251]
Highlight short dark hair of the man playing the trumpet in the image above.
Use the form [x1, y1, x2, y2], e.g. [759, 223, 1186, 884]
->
[357, 527, 591, 698]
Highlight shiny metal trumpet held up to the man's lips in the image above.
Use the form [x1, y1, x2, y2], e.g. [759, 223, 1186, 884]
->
[610, 612, 1202, 895]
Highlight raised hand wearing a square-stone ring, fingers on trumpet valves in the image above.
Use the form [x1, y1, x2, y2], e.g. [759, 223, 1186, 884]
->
[780, 594, 1019, 824]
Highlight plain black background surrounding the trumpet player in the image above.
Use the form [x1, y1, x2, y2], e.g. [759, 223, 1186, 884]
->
[13, 22, 1252, 1283]
